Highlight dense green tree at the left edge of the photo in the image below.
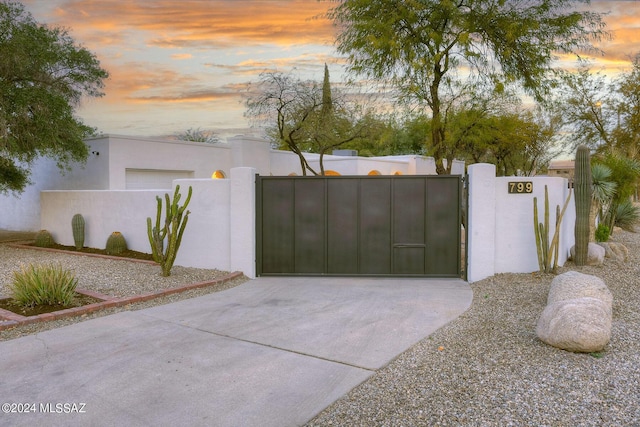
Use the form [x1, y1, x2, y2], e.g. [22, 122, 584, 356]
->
[0, 1, 108, 193]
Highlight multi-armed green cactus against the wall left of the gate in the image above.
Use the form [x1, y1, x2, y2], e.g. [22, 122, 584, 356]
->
[147, 185, 192, 277]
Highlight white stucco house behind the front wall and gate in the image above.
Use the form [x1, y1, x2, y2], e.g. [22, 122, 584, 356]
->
[0, 135, 464, 231]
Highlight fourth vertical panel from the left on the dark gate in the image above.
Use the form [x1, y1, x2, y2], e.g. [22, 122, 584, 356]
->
[359, 178, 391, 274]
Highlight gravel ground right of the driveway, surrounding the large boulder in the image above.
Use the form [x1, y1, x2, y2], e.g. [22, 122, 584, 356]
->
[308, 231, 640, 427]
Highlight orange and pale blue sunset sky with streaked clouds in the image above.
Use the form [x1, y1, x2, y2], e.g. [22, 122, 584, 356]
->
[22, 0, 640, 137]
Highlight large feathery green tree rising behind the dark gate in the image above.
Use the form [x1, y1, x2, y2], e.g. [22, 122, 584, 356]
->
[328, 0, 607, 174]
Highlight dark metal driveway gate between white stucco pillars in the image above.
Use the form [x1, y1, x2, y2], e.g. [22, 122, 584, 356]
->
[256, 175, 461, 277]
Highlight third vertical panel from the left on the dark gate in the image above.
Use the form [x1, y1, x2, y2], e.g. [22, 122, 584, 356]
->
[327, 179, 359, 274]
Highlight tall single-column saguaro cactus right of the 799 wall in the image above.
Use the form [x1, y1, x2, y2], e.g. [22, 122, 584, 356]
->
[573, 145, 591, 266]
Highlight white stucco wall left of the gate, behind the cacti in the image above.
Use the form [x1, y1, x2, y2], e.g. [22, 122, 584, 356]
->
[42, 168, 255, 277]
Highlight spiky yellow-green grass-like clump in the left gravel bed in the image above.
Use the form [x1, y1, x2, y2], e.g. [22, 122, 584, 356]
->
[9, 264, 78, 307]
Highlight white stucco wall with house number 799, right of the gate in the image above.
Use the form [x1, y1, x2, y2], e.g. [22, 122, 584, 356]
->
[467, 164, 575, 282]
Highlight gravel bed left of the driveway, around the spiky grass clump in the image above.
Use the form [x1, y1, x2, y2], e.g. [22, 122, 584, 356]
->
[0, 244, 247, 341]
